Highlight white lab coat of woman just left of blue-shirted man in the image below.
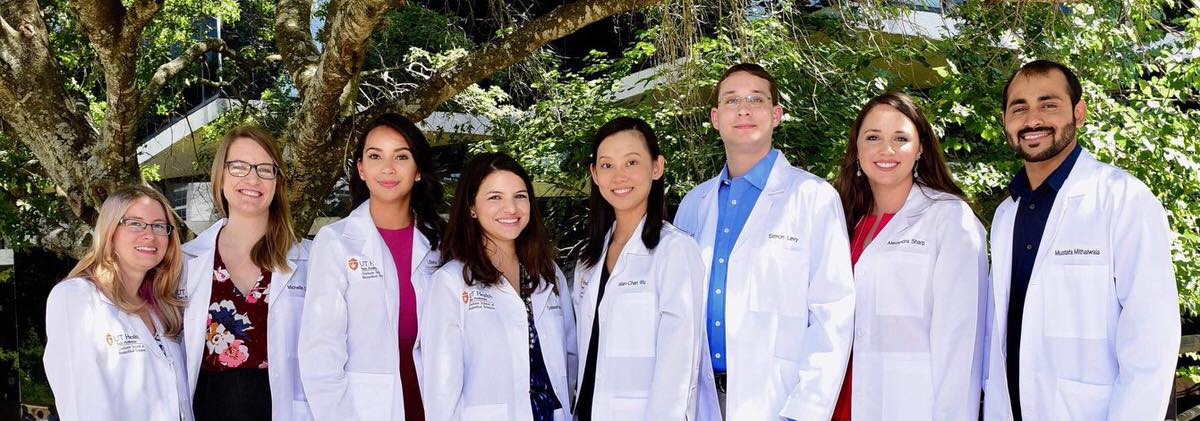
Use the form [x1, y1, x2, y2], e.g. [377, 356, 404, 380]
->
[571, 216, 708, 421]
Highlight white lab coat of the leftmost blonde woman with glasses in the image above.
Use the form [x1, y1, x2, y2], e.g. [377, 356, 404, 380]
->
[42, 277, 192, 421]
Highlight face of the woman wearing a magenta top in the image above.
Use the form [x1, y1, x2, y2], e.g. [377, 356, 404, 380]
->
[358, 126, 419, 203]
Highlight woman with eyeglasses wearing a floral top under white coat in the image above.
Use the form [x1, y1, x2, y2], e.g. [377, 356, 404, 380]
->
[182, 127, 310, 421]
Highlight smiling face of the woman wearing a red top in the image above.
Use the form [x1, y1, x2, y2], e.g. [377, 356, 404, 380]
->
[857, 104, 922, 188]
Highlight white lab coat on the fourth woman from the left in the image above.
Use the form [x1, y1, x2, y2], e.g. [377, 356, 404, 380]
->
[418, 260, 577, 421]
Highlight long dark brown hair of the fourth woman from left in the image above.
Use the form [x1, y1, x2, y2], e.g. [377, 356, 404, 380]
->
[440, 152, 558, 294]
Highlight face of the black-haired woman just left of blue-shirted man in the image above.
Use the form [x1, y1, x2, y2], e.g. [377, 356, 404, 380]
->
[590, 130, 664, 218]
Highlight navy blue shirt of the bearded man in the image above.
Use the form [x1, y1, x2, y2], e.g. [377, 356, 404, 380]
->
[1004, 143, 1082, 421]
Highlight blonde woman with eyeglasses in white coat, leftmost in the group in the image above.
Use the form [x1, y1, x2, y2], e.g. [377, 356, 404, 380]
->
[42, 186, 192, 421]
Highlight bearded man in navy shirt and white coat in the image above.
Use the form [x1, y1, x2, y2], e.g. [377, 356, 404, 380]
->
[984, 60, 1180, 421]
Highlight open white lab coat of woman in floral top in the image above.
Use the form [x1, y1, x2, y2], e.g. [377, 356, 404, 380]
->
[180, 218, 312, 421]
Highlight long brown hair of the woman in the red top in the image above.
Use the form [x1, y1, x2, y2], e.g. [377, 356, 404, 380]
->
[834, 92, 966, 234]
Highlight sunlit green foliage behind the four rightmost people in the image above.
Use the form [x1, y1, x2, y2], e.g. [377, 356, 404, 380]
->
[475, 1, 1200, 315]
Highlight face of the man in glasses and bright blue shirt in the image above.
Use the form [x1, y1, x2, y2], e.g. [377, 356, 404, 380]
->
[708, 72, 784, 154]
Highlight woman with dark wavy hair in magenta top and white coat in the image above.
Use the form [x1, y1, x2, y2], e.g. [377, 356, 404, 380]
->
[300, 114, 444, 420]
